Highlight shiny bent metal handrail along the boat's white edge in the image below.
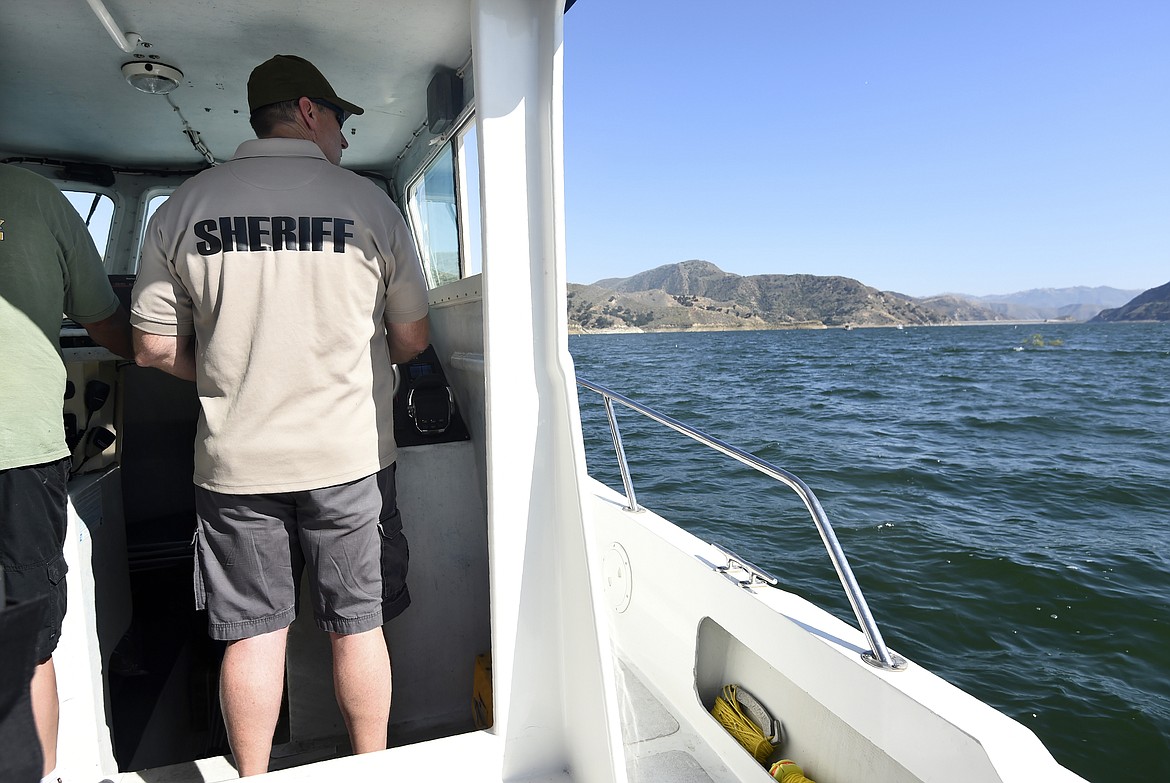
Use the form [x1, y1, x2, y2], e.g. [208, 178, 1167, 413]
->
[577, 376, 906, 671]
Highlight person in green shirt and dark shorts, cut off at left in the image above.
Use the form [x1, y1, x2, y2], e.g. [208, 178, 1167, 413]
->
[0, 164, 133, 781]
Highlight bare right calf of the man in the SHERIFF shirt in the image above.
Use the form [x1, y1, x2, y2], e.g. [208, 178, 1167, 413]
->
[329, 627, 391, 753]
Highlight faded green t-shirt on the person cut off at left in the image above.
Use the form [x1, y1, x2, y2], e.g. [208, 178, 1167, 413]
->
[0, 164, 118, 471]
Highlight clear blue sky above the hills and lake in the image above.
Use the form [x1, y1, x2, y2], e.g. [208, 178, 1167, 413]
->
[564, 0, 1170, 296]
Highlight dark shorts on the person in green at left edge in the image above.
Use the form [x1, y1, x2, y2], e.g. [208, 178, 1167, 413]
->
[0, 456, 69, 661]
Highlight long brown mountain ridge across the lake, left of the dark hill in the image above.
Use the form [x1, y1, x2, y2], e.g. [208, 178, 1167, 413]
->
[567, 260, 1160, 331]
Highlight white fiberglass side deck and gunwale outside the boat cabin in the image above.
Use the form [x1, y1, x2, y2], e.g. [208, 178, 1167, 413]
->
[592, 485, 1080, 783]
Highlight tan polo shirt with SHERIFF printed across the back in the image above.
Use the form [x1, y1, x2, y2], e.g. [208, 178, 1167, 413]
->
[131, 139, 427, 494]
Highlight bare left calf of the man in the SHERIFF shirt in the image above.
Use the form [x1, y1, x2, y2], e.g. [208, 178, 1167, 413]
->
[220, 627, 289, 777]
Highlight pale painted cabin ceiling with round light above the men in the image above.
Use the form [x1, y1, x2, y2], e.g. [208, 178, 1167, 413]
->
[0, 0, 472, 170]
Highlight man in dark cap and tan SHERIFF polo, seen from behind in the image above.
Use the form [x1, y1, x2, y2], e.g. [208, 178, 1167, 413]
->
[131, 55, 429, 776]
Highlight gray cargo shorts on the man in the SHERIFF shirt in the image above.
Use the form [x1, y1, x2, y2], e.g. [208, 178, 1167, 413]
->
[195, 465, 411, 640]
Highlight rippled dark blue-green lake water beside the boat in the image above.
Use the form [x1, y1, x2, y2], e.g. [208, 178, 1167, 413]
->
[569, 324, 1170, 782]
